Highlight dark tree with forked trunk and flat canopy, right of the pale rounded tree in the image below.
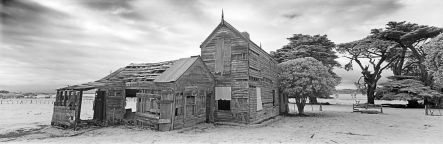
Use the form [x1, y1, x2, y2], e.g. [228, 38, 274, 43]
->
[337, 36, 398, 104]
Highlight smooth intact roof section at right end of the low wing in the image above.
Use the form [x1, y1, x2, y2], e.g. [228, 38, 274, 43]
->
[154, 57, 198, 82]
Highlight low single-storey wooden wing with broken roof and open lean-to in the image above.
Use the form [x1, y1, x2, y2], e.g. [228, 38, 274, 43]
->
[52, 56, 214, 131]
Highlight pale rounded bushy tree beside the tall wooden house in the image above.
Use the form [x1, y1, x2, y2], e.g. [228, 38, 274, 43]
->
[279, 57, 338, 115]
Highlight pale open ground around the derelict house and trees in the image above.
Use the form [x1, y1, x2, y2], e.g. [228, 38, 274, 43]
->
[0, 95, 443, 143]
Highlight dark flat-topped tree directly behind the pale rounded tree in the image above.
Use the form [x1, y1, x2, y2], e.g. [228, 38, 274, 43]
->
[271, 34, 341, 103]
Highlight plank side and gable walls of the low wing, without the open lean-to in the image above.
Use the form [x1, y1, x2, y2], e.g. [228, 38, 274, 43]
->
[132, 59, 214, 131]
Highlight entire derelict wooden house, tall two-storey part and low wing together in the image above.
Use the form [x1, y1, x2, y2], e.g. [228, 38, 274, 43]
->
[52, 16, 285, 131]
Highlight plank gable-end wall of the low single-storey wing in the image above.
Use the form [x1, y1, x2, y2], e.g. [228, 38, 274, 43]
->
[174, 59, 215, 129]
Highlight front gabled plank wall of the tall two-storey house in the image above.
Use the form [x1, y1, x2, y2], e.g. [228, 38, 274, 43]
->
[201, 27, 253, 123]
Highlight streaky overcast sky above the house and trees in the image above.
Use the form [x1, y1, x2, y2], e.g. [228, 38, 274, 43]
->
[0, 0, 443, 92]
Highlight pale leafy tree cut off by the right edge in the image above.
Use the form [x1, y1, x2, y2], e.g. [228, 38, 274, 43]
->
[424, 34, 443, 89]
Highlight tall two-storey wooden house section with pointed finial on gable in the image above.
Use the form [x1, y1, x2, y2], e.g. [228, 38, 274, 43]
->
[200, 15, 280, 123]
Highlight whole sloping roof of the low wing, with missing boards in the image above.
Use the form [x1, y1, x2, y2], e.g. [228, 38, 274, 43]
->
[61, 56, 199, 90]
